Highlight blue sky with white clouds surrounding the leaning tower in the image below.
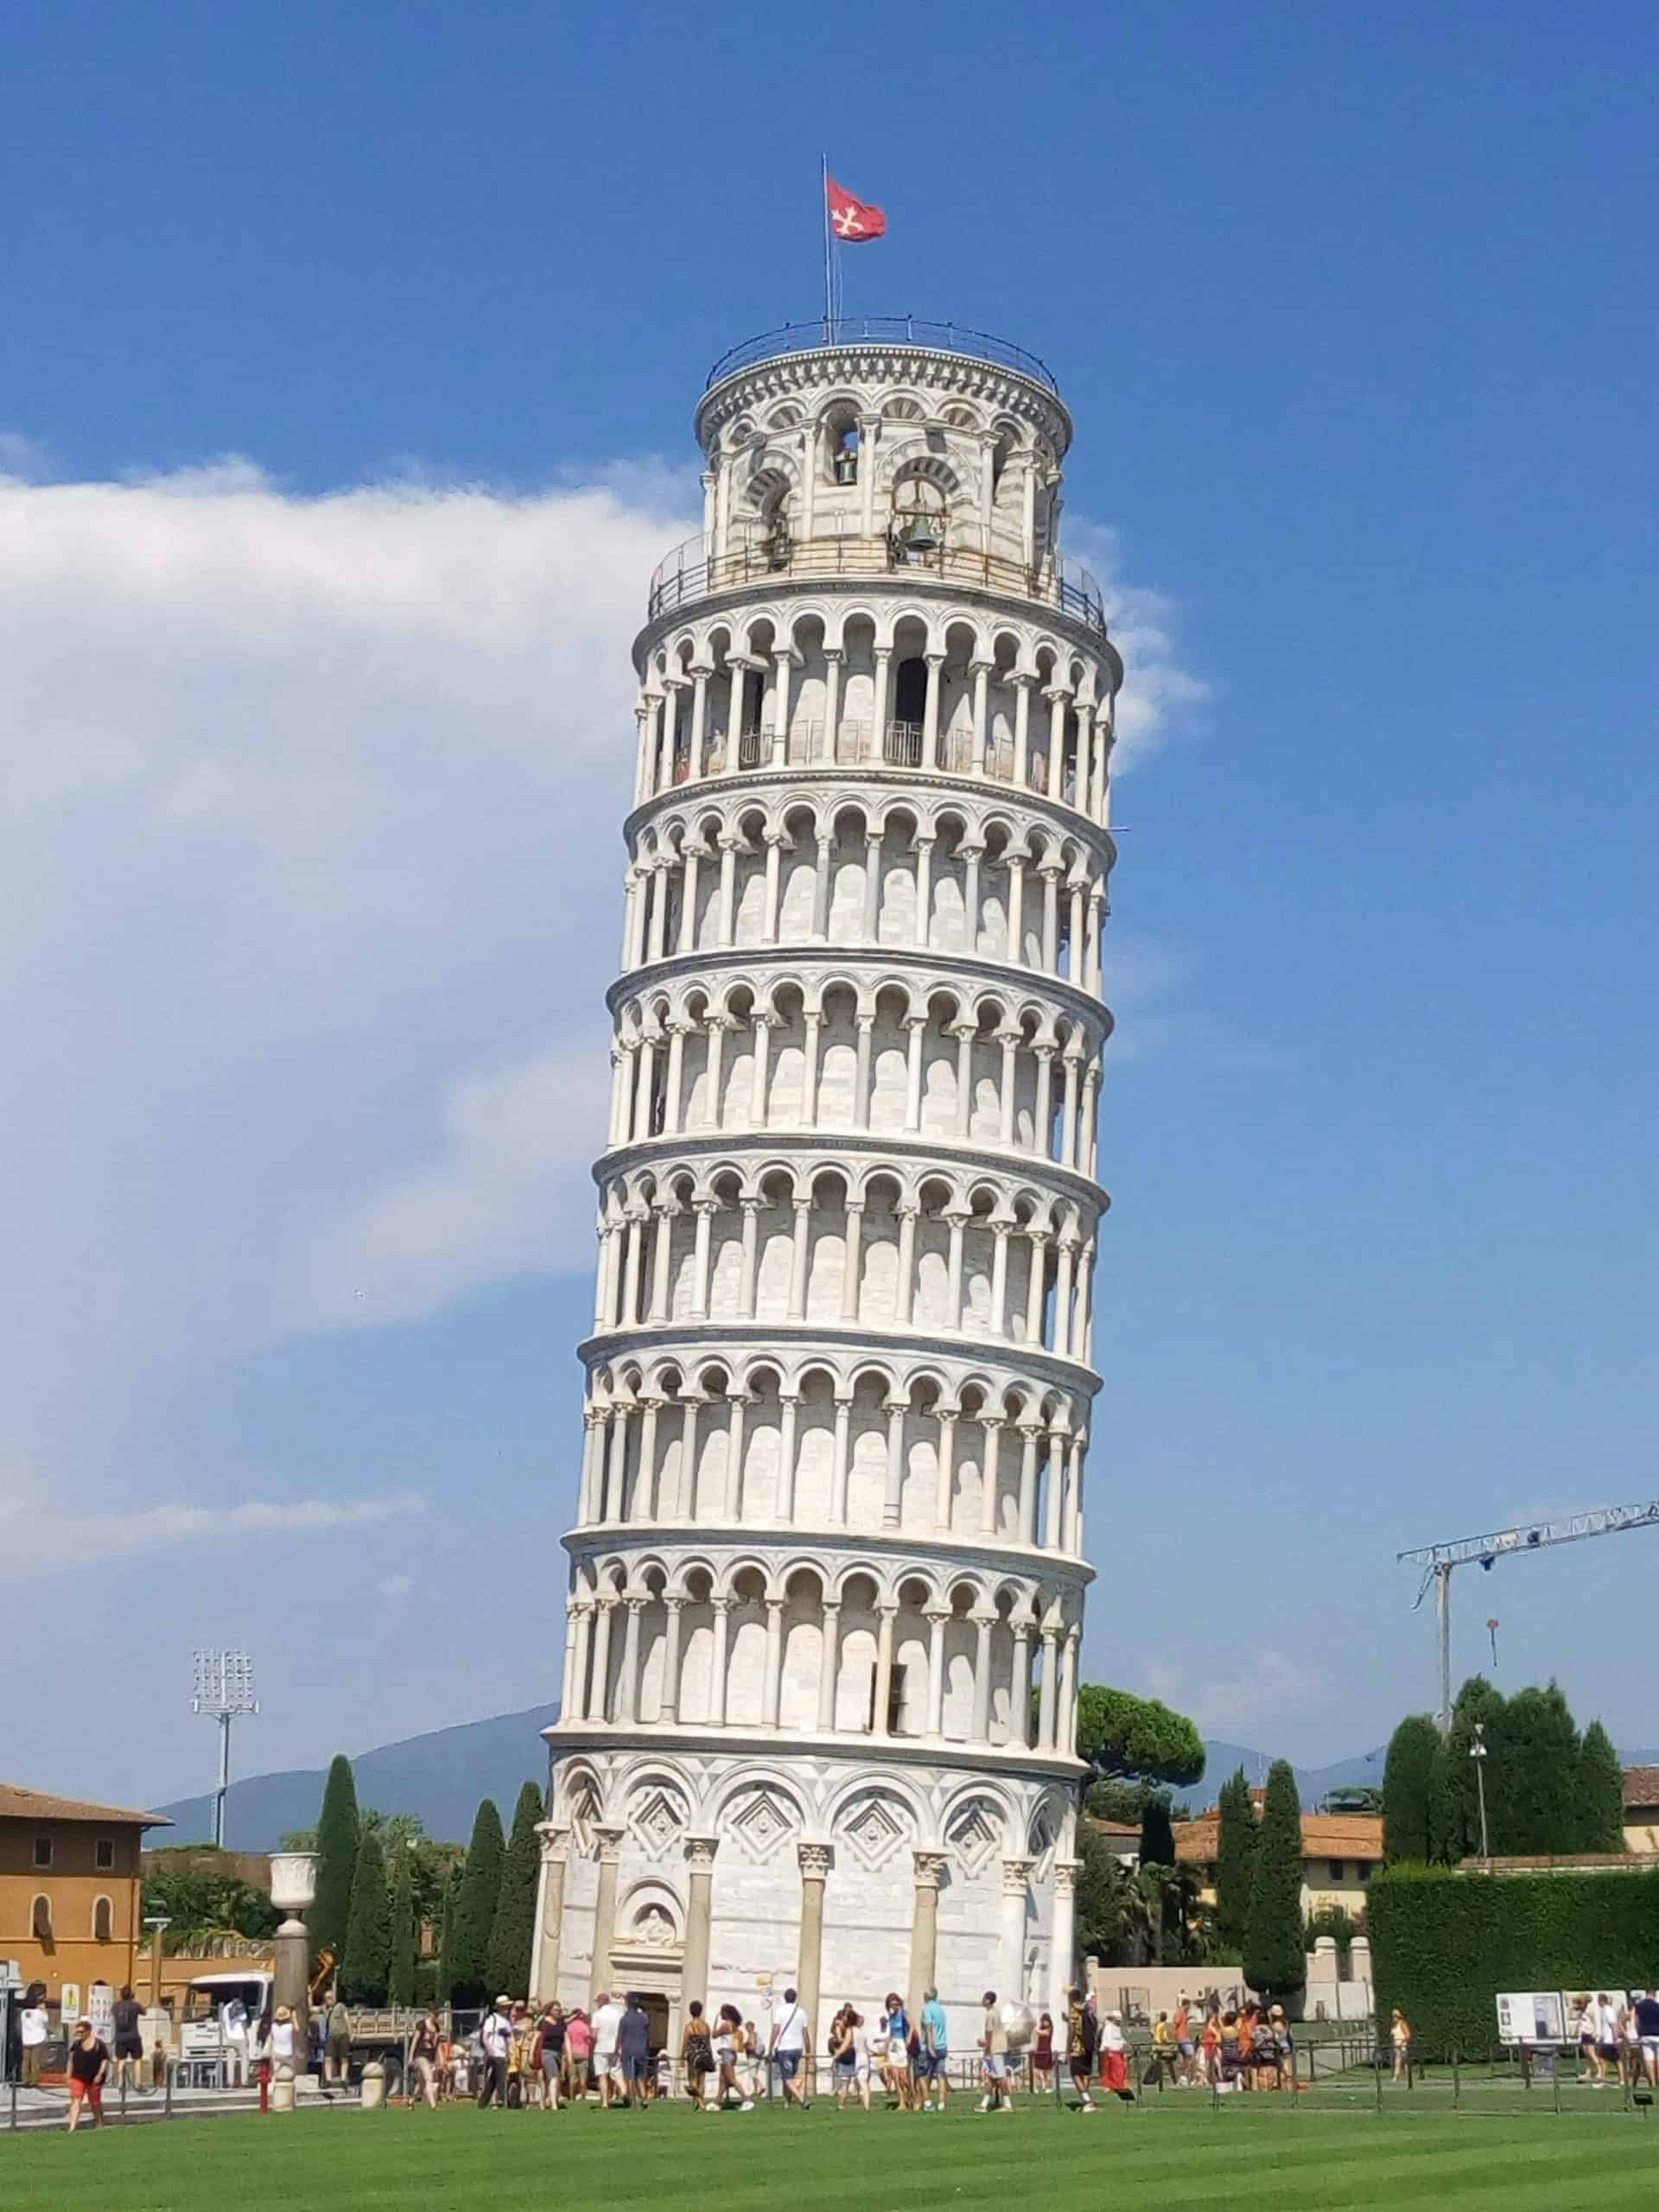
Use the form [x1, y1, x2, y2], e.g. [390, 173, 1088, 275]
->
[0, 0, 1659, 1798]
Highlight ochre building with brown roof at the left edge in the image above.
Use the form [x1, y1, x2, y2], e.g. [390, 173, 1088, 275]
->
[0, 1783, 170, 2004]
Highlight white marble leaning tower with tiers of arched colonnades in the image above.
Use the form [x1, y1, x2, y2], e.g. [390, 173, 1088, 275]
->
[533, 321, 1122, 2049]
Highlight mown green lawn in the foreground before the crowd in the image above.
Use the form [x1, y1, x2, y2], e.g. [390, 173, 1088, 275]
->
[0, 2097, 1659, 2212]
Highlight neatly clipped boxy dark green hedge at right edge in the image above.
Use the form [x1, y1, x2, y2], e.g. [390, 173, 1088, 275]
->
[1367, 1865, 1659, 2059]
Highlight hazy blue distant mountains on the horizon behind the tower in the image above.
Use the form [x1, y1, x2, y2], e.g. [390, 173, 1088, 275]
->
[153, 1706, 1659, 1852]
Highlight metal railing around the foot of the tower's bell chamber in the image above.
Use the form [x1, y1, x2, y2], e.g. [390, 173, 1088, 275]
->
[646, 526, 1106, 637]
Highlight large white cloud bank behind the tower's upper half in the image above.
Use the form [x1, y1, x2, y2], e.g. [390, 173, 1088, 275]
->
[0, 442, 1197, 1541]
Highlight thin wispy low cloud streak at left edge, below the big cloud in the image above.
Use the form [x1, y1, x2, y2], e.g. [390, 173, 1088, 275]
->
[0, 1491, 425, 1581]
